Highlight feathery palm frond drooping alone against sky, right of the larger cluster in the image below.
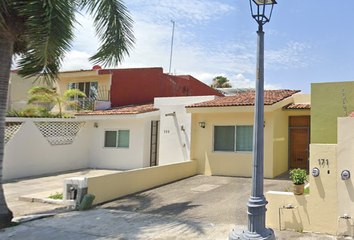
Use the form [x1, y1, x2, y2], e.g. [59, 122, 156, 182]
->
[79, 0, 135, 66]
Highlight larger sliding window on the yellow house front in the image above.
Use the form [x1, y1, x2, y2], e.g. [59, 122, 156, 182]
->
[214, 126, 253, 152]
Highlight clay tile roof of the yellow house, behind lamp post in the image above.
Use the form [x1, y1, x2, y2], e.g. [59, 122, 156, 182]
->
[187, 89, 300, 108]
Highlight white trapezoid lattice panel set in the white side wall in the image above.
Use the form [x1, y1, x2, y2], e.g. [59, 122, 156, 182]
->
[34, 122, 85, 145]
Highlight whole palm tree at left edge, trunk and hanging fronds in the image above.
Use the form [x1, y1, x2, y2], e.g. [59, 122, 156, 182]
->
[0, 0, 135, 228]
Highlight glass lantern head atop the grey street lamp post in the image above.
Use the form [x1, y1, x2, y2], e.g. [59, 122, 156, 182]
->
[250, 0, 277, 26]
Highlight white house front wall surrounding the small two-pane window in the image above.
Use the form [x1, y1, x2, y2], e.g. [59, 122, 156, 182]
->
[89, 114, 159, 170]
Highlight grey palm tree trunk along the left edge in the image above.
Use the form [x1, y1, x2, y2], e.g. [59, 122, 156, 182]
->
[0, 34, 14, 229]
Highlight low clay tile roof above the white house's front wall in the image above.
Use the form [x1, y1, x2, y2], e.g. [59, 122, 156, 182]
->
[76, 103, 159, 116]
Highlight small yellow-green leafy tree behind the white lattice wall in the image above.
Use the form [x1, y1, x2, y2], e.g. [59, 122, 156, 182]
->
[28, 86, 86, 117]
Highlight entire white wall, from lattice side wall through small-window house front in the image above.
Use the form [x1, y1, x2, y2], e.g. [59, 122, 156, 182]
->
[3, 112, 159, 180]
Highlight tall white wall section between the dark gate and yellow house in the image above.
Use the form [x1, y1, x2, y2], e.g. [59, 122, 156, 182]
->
[154, 96, 218, 165]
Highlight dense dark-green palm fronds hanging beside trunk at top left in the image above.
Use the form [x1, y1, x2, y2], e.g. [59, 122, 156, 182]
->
[17, 0, 75, 84]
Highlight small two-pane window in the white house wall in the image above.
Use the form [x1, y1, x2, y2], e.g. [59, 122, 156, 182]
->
[104, 130, 130, 148]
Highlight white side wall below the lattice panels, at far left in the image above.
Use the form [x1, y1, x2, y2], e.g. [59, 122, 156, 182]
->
[3, 118, 91, 180]
